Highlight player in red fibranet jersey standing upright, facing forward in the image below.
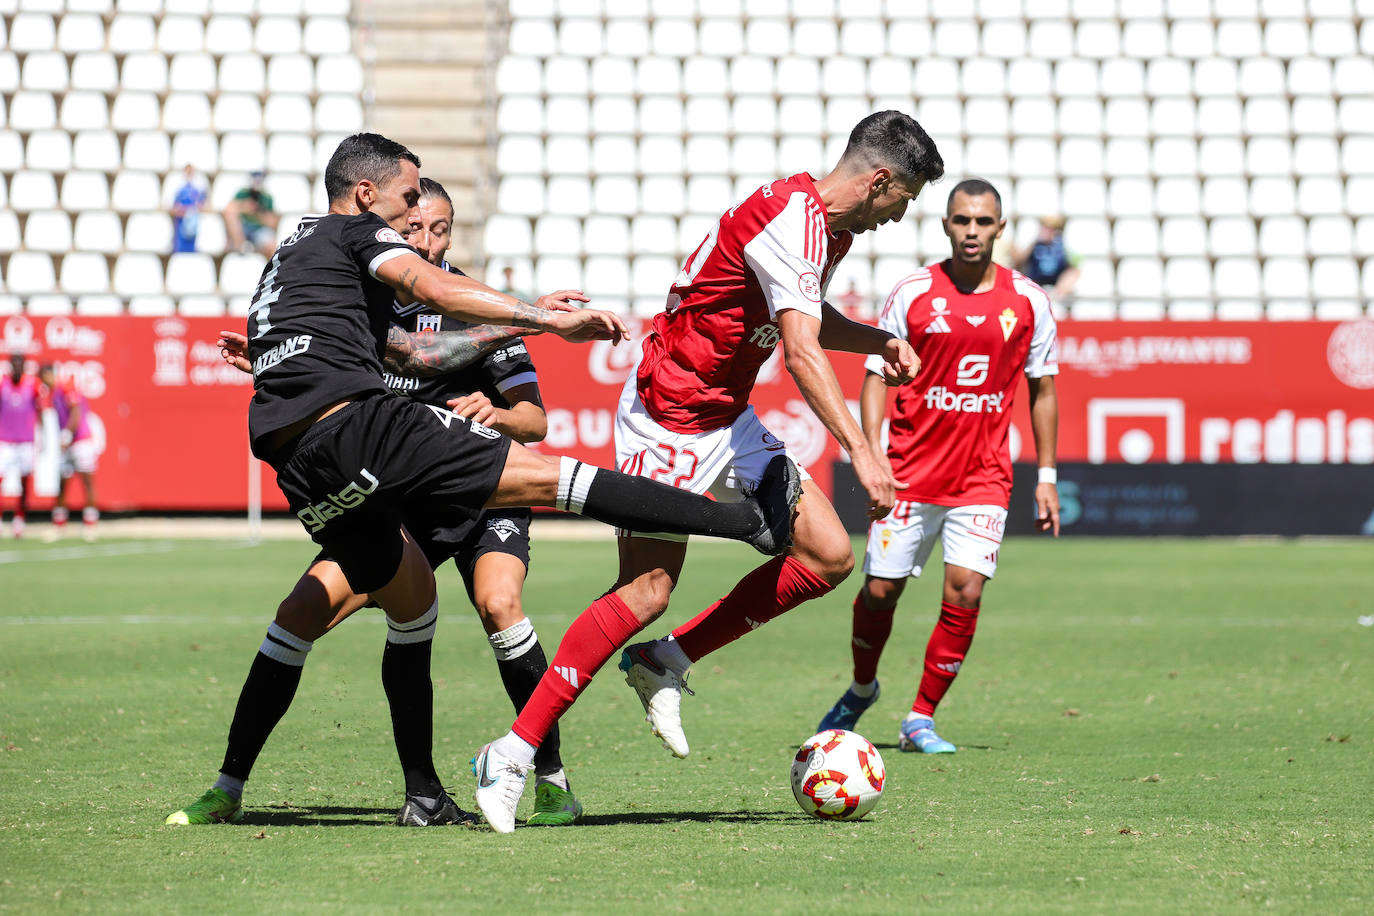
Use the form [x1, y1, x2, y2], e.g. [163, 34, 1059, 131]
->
[820, 179, 1059, 754]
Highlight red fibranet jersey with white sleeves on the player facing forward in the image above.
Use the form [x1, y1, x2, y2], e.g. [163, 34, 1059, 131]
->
[864, 261, 1059, 507]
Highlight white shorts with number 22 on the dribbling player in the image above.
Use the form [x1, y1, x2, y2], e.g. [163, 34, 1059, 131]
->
[616, 374, 811, 541]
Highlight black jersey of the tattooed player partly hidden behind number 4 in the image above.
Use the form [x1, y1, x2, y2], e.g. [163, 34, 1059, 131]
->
[382, 261, 539, 409]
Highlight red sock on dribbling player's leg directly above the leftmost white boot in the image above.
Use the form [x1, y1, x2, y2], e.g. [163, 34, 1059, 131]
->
[511, 592, 643, 747]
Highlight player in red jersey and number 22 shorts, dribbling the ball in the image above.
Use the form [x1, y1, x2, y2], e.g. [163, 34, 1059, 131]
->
[474, 111, 944, 831]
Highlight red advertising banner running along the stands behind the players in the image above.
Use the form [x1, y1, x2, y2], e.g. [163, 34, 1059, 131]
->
[0, 314, 1374, 511]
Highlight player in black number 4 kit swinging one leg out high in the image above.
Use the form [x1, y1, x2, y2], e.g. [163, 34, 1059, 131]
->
[168, 133, 800, 832]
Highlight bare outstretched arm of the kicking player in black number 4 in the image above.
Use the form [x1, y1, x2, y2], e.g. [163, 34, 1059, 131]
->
[376, 254, 629, 343]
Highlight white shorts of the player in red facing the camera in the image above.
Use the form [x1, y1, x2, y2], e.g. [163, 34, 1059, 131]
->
[863, 500, 1007, 580]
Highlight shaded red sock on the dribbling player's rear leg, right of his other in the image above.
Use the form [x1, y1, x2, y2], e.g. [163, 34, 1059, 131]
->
[673, 556, 834, 662]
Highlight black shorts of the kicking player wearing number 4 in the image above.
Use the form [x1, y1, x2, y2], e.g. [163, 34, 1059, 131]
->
[269, 394, 511, 593]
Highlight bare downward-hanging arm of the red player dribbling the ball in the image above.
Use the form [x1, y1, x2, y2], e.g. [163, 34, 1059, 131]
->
[778, 309, 901, 519]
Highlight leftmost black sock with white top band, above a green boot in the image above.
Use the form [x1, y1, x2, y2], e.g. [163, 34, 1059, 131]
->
[220, 622, 313, 781]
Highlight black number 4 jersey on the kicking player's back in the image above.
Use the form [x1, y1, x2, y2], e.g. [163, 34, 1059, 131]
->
[247, 213, 415, 457]
